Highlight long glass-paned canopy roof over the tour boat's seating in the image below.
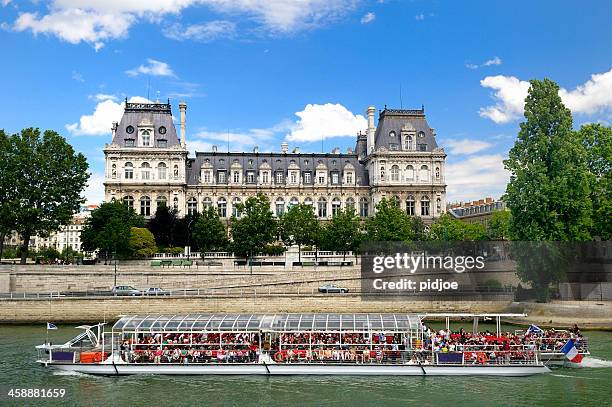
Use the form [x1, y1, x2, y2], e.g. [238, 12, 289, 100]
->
[113, 314, 421, 333]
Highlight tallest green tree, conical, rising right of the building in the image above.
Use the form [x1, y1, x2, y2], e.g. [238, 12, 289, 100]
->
[504, 79, 591, 241]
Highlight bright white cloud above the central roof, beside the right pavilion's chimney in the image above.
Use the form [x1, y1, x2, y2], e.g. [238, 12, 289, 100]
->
[287, 103, 367, 142]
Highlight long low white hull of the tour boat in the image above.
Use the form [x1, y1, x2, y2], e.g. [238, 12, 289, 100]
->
[43, 362, 550, 376]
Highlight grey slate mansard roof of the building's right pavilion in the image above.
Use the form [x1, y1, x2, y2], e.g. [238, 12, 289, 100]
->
[374, 107, 438, 152]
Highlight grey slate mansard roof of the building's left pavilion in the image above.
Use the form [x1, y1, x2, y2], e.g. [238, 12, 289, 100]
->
[113, 98, 180, 147]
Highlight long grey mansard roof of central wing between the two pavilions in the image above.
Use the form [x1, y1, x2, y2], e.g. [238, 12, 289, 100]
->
[187, 152, 369, 185]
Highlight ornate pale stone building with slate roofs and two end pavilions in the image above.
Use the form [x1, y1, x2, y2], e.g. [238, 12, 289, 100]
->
[104, 100, 446, 222]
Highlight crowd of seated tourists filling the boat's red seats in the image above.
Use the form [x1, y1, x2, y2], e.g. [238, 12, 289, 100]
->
[115, 325, 582, 364]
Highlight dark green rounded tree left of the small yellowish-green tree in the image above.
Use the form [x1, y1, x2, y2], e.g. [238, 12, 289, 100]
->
[81, 200, 144, 258]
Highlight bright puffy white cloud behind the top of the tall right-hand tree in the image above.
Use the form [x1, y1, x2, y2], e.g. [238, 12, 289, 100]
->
[479, 69, 612, 123]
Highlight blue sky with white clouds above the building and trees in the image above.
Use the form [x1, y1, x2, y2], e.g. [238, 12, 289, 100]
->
[0, 0, 612, 202]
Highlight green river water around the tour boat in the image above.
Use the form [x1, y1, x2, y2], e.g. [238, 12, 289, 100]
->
[0, 325, 612, 407]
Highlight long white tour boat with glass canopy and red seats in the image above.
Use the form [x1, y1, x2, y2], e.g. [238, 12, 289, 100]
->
[36, 314, 549, 376]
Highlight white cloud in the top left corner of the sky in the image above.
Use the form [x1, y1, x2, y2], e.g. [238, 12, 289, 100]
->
[13, 8, 134, 50]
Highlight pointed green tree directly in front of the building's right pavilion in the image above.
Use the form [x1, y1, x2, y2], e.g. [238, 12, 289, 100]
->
[365, 198, 416, 242]
